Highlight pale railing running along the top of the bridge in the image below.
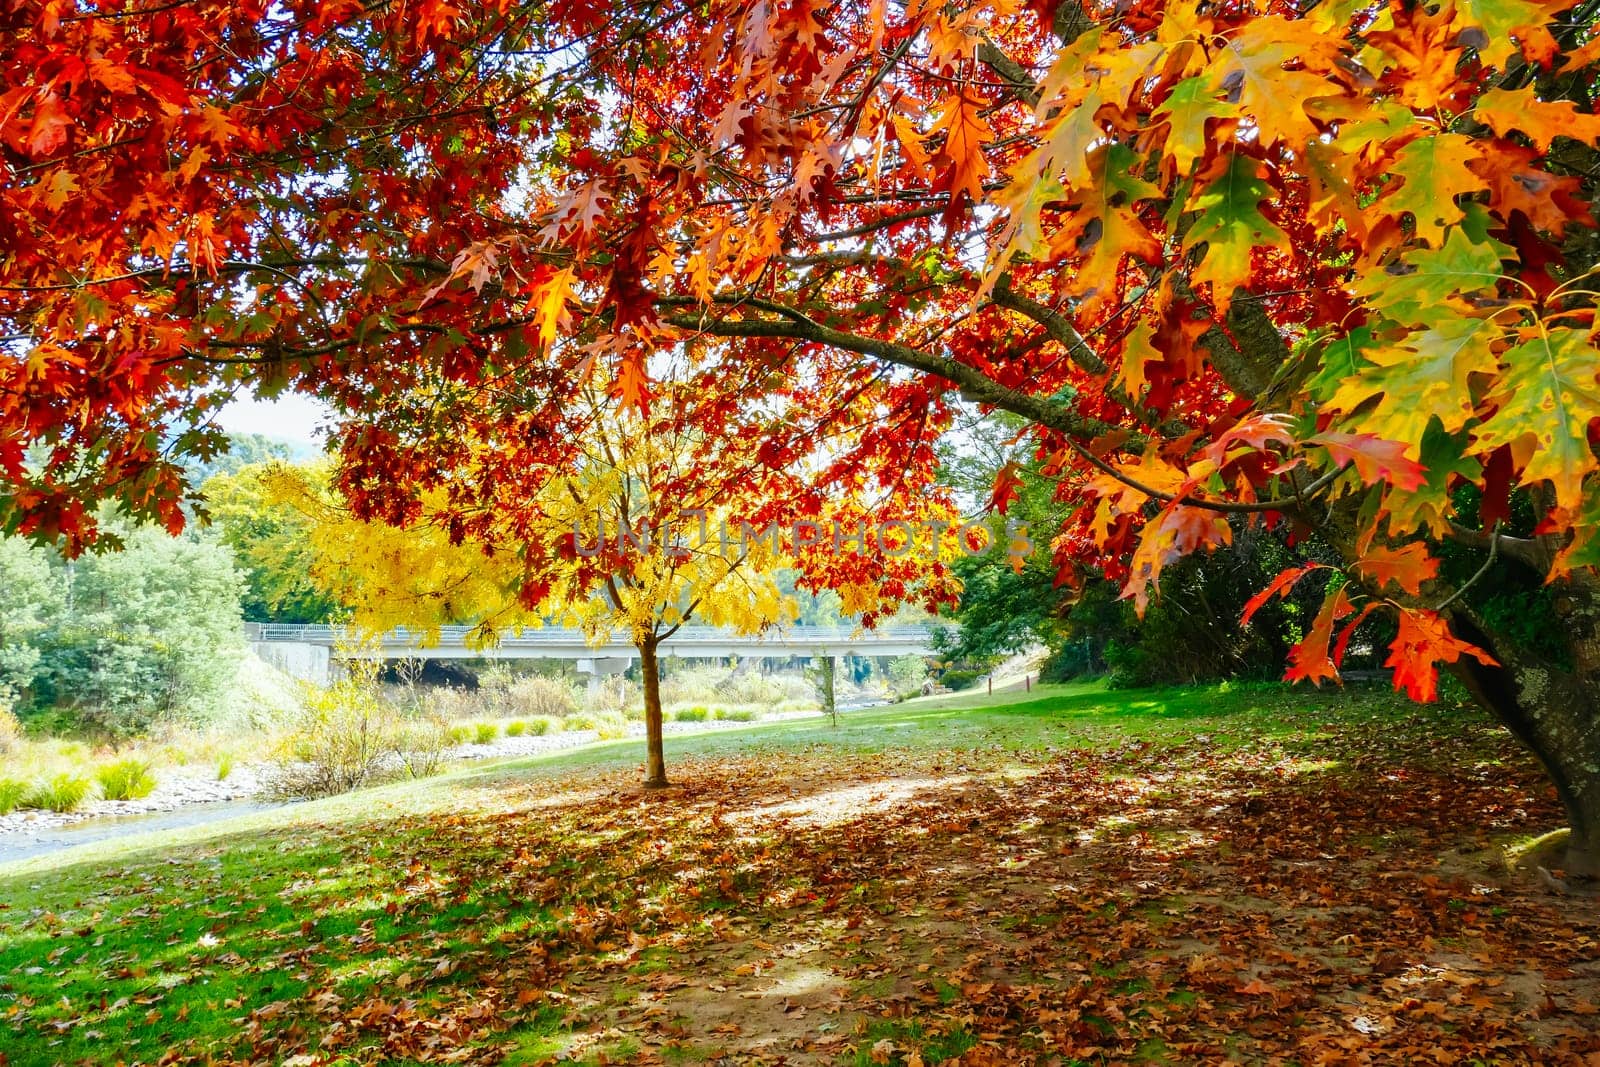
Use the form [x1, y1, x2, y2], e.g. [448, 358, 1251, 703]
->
[245, 622, 931, 654]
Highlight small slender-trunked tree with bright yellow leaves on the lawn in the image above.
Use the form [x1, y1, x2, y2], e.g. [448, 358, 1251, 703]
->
[270, 386, 962, 787]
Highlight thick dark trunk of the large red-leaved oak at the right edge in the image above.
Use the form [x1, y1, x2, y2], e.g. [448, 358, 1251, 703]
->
[1451, 582, 1600, 878]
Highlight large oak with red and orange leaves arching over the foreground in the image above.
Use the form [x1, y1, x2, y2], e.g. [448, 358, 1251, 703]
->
[0, 0, 1600, 867]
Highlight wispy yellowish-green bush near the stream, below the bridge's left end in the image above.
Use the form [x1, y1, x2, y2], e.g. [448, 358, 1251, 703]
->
[270, 664, 402, 797]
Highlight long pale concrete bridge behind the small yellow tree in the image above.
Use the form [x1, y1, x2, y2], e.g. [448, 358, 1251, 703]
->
[245, 622, 933, 686]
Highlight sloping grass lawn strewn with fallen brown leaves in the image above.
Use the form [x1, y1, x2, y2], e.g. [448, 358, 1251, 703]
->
[0, 686, 1600, 1067]
